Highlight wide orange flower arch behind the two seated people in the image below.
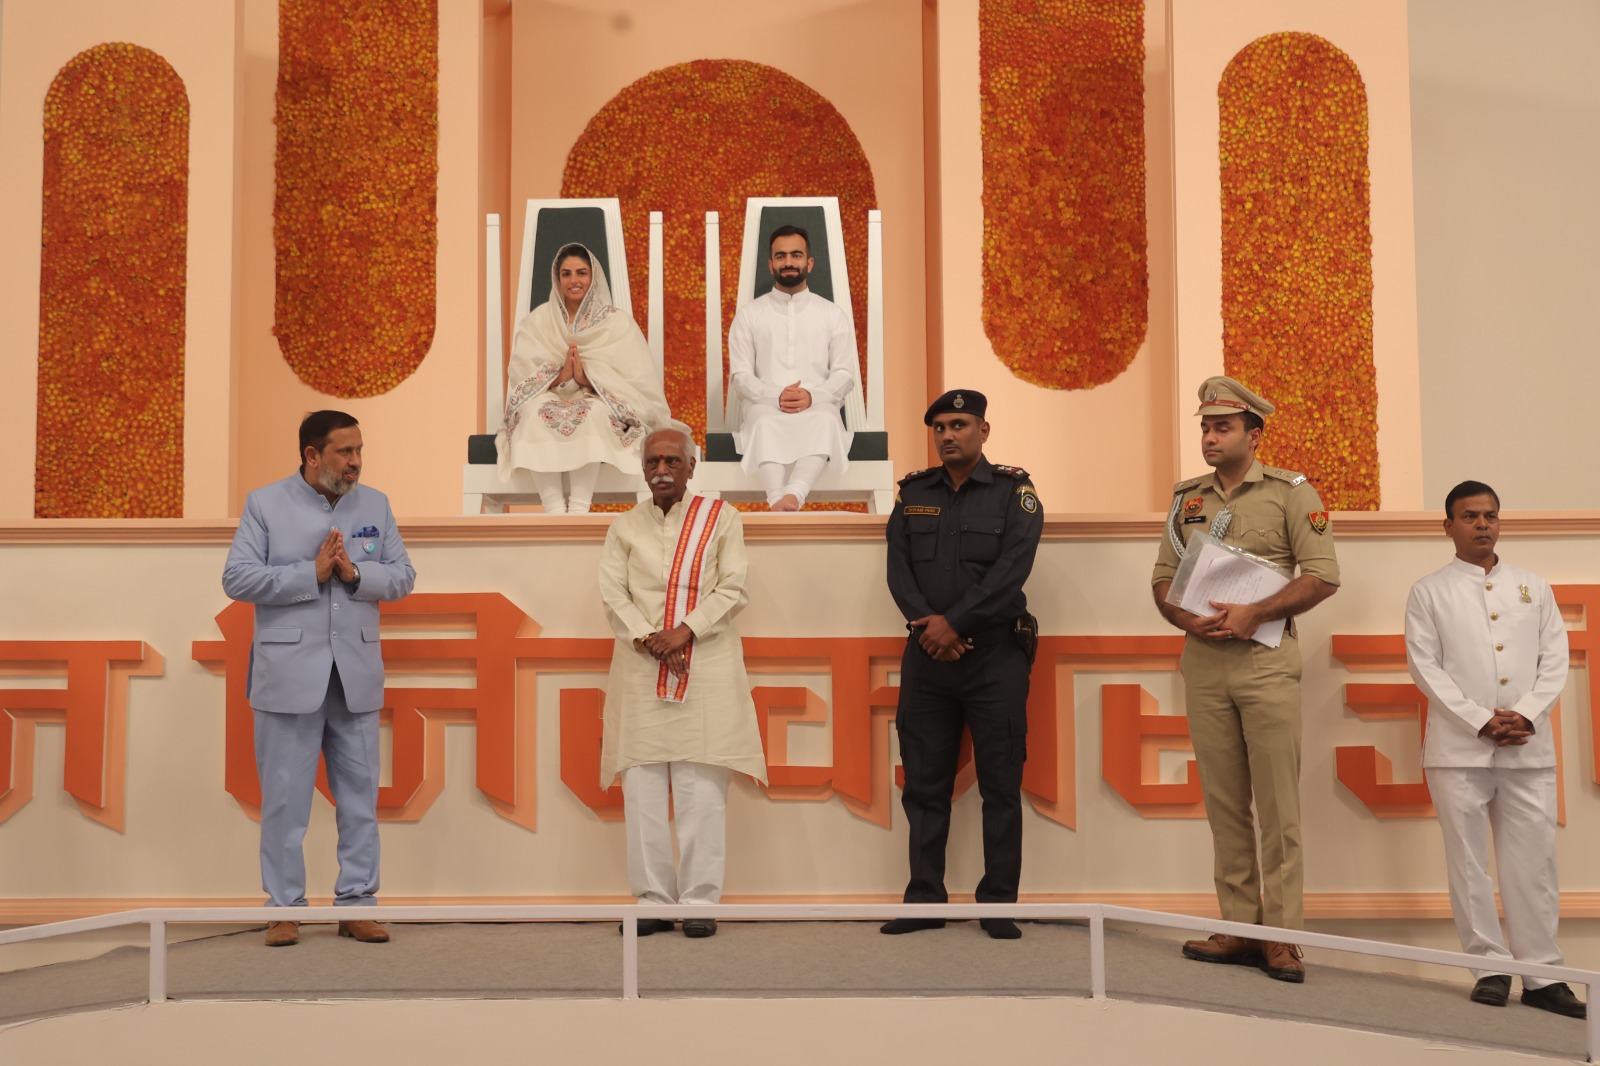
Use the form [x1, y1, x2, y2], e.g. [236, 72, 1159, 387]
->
[562, 59, 877, 434]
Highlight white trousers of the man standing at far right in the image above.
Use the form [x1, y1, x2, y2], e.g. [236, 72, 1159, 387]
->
[1424, 767, 1562, 988]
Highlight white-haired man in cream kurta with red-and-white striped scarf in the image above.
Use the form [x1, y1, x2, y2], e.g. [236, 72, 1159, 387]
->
[600, 429, 766, 936]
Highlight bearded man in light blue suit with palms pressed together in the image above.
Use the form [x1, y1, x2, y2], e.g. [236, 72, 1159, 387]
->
[222, 411, 416, 948]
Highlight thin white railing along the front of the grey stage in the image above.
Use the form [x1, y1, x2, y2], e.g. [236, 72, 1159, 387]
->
[0, 903, 1600, 1063]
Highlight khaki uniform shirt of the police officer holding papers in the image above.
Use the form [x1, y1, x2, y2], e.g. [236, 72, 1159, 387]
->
[1150, 459, 1339, 586]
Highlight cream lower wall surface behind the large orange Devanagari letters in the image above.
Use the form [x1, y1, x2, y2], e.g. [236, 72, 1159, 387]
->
[0, 515, 1600, 965]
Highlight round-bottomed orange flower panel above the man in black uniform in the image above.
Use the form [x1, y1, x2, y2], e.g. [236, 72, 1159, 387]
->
[978, 0, 1150, 389]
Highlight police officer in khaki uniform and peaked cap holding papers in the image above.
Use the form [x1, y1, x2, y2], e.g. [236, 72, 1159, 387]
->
[1150, 376, 1339, 983]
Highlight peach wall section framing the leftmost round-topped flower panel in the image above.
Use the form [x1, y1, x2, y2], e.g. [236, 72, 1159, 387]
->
[0, 0, 243, 519]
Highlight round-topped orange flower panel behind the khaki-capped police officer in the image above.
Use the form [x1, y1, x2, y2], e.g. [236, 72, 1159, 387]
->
[1218, 34, 1379, 511]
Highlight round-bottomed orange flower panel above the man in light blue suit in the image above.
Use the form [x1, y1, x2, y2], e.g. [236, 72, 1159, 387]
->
[272, 0, 438, 397]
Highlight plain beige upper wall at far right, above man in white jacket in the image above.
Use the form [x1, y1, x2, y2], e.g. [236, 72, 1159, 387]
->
[1410, 0, 1600, 509]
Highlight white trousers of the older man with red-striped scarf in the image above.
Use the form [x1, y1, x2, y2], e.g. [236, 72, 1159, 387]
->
[622, 762, 731, 903]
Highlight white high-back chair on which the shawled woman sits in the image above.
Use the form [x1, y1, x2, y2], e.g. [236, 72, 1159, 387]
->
[461, 197, 662, 514]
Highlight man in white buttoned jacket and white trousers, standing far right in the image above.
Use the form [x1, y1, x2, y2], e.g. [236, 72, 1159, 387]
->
[1405, 482, 1586, 1018]
